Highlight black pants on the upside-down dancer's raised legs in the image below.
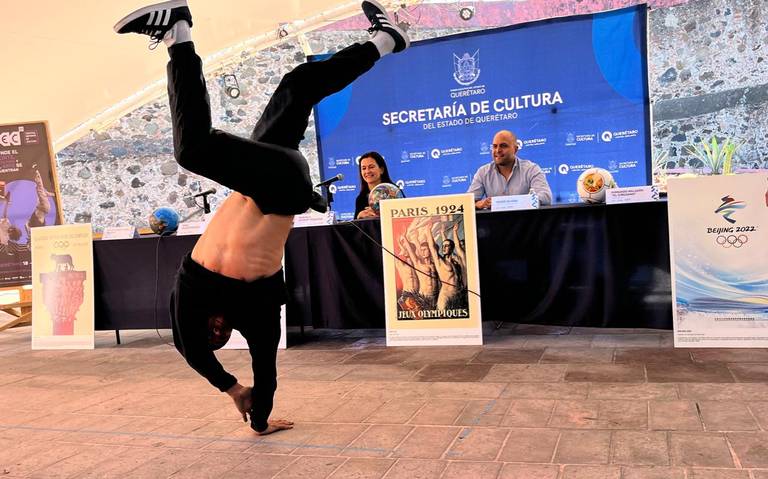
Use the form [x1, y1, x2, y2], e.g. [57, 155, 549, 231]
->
[168, 42, 379, 215]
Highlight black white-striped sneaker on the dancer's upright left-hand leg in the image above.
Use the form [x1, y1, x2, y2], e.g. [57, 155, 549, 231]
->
[114, 0, 192, 45]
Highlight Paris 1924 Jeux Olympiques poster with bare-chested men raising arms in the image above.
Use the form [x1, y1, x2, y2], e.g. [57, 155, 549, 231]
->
[381, 194, 483, 346]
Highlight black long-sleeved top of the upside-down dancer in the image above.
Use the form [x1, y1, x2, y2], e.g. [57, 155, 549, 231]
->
[171, 254, 286, 431]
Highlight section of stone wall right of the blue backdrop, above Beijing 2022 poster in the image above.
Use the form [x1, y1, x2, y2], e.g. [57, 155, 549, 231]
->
[648, 0, 768, 168]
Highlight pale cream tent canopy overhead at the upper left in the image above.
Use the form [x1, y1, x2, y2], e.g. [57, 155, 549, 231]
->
[0, 0, 370, 150]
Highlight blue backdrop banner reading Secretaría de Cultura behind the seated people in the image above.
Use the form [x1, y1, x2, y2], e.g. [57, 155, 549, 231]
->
[311, 5, 651, 220]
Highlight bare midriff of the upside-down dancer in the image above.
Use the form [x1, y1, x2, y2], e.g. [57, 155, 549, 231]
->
[192, 192, 293, 281]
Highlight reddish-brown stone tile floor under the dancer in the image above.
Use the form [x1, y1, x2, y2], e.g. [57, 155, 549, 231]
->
[0, 324, 768, 479]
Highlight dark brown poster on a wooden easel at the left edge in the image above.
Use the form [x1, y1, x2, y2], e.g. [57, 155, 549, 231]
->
[0, 122, 62, 287]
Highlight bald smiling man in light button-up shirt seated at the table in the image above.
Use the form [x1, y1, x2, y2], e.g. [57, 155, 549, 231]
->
[467, 130, 552, 209]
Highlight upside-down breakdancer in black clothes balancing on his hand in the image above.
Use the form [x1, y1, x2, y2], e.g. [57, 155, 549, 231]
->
[115, 0, 409, 435]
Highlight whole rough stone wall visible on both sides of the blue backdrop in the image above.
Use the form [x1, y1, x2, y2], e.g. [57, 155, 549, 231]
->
[58, 0, 768, 231]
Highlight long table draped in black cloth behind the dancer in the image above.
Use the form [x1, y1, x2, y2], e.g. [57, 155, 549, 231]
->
[94, 202, 672, 330]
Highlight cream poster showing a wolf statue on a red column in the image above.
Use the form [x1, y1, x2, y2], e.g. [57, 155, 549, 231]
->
[31, 223, 94, 349]
